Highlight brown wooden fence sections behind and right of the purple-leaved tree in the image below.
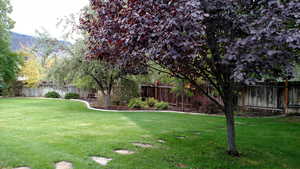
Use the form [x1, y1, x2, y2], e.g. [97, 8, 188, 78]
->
[141, 82, 300, 112]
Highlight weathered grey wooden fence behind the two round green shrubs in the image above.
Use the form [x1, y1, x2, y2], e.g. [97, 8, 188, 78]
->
[19, 85, 94, 98]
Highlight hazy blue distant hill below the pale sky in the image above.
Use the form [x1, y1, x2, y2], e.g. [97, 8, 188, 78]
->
[11, 32, 71, 51]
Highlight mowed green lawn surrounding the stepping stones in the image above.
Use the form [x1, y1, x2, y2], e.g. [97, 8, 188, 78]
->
[0, 98, 300, 169]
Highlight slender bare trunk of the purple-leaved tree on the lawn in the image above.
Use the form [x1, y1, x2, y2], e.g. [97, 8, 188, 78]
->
[224, 96, 239, 156]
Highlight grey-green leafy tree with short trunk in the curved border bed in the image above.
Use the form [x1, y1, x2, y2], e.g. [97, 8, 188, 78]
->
[49, 39, 126, 107]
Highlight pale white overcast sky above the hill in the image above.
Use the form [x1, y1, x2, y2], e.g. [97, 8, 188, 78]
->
[10, 0, 89, 39]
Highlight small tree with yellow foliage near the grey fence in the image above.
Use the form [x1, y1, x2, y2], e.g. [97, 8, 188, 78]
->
[20, 51, 42, 87]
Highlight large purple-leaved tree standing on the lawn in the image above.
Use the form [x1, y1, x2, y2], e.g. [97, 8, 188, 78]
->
[81, 0, 300, 156]
